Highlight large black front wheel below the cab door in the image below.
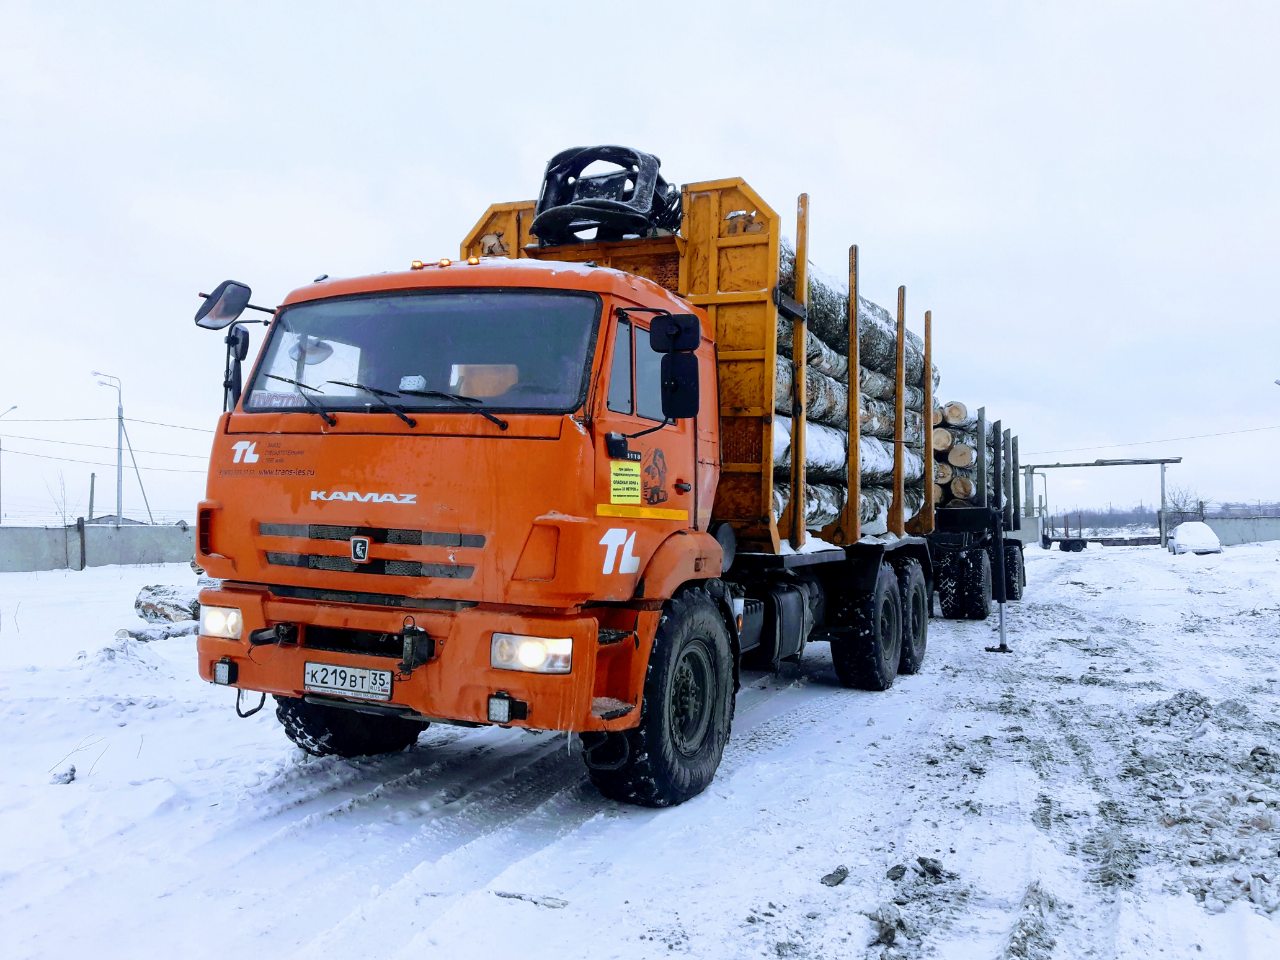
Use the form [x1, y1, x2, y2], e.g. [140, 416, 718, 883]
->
[584, 590, 733, 806]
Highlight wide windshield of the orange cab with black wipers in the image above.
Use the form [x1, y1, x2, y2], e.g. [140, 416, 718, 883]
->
[244, 289, 600, 413]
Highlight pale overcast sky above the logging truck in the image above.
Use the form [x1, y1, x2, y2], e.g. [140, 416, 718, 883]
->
[0, 0, 1280, 524]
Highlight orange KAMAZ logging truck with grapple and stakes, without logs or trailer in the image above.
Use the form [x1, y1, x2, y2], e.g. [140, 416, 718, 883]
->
[196, 147, 933, 806]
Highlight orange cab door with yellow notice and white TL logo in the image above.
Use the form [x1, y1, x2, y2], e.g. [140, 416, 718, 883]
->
[595, 307, 696, 599]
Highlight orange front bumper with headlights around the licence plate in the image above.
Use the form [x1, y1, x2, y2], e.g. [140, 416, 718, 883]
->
[196, 586, 658, 731]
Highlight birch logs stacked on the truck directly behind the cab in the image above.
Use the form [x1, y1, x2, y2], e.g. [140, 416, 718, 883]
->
[773, 243, 938, 534]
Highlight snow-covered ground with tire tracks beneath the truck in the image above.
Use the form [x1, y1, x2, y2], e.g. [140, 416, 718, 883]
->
[0, 544, 1280, 960]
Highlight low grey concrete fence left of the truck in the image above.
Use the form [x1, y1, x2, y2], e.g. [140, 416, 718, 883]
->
[0, 520, 196, 573]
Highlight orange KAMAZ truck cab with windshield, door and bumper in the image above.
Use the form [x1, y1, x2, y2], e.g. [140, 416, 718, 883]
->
[197, 260, 721, 731]
